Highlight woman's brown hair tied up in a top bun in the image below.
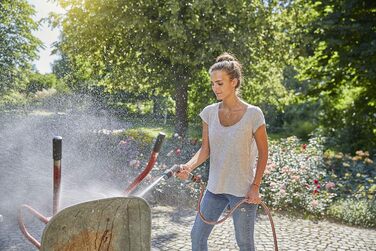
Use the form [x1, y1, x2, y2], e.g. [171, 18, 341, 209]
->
[209, 52, 243, 89]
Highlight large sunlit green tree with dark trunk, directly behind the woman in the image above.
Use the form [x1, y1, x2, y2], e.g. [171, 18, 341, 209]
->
[55, 0, 285, 133]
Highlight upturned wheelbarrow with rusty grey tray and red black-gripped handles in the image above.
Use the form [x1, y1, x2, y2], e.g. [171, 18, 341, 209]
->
[18, 133, 165, 251]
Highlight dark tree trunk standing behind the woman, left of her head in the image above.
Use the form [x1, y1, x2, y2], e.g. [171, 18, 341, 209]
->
[175, 75, 188, 137]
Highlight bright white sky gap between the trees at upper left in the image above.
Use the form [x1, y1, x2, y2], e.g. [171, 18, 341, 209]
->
[27, 0, 64, 74]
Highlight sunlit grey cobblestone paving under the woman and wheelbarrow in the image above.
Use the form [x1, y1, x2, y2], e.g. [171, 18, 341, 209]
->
[0, 206, 376, 251]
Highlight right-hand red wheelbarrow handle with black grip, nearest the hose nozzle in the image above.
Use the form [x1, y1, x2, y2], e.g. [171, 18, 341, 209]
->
[125, 132, 166, 196]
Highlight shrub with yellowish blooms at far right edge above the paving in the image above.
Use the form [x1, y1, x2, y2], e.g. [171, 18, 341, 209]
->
[324, 150, 376, 227]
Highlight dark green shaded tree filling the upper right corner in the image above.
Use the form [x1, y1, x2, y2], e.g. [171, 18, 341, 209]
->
[300, 0, 376, 152]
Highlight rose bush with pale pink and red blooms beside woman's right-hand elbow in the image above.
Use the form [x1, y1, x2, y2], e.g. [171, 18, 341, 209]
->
[261, 136, 336, 216]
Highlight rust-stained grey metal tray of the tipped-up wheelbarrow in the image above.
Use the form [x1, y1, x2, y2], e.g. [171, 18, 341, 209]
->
[41, 197, 151, 251]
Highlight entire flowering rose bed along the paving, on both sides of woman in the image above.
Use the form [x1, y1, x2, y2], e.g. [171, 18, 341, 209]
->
[86, 123, 376, 227]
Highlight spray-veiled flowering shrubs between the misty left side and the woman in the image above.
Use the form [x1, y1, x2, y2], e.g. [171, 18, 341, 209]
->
[104, 128, 205, 207]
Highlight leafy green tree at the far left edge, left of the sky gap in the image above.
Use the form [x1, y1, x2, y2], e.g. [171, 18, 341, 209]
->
[0, 0, 41, 96]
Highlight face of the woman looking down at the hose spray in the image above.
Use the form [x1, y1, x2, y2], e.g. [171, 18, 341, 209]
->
[210, 70, 237, 100]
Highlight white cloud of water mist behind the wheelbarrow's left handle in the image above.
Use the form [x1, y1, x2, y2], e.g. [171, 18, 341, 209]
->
[0, 94, 144, 250]
